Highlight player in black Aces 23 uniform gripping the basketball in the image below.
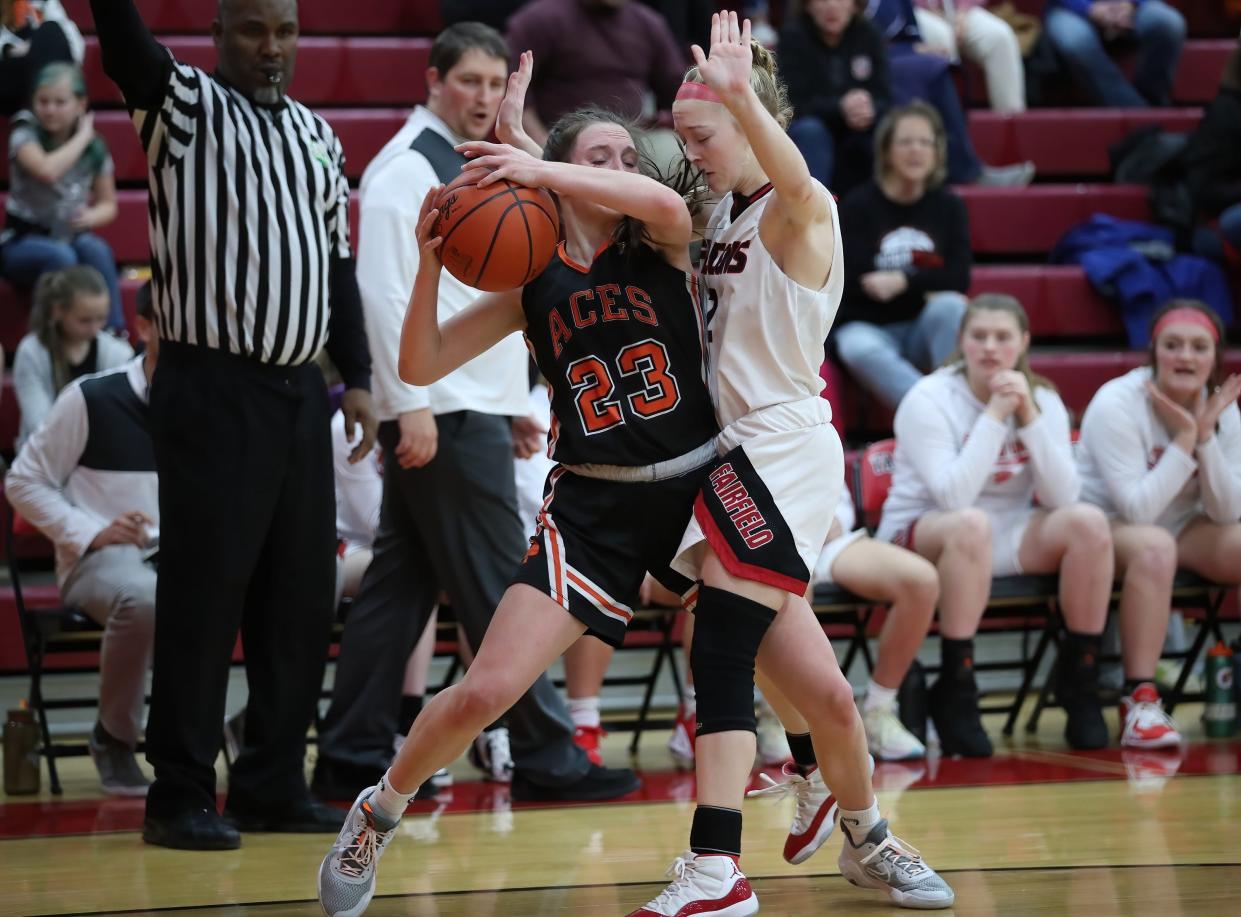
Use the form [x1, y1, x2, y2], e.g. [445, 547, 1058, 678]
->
[319, 109, 724, 915]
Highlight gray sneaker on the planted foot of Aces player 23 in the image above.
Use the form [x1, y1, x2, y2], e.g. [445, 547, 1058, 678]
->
[319, 787, 400, 917]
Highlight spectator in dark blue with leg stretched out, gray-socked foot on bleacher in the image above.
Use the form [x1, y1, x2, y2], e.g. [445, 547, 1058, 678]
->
[858, 0, 1034, 186]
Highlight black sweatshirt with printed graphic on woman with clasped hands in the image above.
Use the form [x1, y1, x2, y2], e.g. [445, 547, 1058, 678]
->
[836, 180, 973, 326]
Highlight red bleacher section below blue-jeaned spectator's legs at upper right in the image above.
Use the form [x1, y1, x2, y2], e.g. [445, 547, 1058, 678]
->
[969, 108, 1203, 177]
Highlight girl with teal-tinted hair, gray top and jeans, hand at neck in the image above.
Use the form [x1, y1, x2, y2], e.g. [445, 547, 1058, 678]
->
[0, 63, 125, 331]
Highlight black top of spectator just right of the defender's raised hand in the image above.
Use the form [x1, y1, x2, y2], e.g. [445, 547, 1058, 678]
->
[779, 14, 892, 132]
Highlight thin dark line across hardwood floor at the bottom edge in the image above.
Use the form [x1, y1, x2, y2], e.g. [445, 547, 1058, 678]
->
[27, 861, 1241, 917]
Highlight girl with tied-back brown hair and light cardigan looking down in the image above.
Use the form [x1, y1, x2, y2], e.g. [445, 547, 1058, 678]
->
[12, 264, 134, 449]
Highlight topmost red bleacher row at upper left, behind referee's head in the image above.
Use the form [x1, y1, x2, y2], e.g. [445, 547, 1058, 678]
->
[63, 0, 443, 35]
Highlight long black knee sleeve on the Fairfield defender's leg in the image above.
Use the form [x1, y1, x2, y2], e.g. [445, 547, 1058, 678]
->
[690, 586, 776, 736]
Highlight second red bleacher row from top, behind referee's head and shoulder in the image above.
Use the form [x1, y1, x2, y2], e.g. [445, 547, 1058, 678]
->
[84, 36, 431, 105]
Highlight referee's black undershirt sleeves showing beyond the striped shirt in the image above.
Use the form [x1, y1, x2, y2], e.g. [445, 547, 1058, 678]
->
[91, 0, 371, 390]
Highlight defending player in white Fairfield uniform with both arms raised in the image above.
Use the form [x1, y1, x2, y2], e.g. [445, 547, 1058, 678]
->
[632, 12, 954, 917]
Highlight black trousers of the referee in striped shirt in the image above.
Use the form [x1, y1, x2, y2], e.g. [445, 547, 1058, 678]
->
[146, 342, 335, 818]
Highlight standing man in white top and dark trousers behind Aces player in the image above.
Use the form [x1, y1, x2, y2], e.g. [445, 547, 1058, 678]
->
[314, 22, 635, 799]
